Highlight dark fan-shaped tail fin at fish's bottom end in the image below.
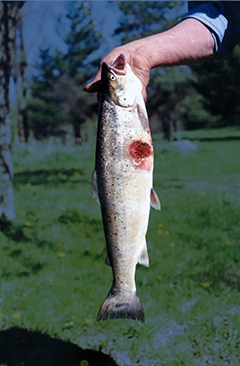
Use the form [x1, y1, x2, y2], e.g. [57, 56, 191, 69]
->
[97, 287, 145, 323]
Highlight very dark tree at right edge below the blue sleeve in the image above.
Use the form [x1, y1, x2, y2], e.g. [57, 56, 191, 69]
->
[192, 46, 240, 127]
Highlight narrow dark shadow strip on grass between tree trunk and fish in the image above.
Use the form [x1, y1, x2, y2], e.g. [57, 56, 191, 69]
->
[14, 169, 87, 186]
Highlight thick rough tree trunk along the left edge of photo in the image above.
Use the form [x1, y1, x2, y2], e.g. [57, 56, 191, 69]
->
[0, 1, 24, 220]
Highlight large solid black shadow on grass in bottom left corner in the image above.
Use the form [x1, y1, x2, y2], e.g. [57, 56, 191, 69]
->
[0, 327, 118, 366]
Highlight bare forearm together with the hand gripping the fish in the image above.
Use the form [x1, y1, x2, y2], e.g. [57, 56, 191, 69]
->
[85, 18, 215, 100]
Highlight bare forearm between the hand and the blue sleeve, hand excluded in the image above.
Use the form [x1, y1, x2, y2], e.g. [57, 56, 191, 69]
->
[126, 19, 214, 69]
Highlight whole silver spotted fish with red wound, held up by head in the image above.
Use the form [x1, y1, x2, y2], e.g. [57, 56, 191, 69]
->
[92, 54, 161, 322]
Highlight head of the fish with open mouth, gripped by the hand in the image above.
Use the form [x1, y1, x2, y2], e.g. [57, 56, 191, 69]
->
[101, 54, 142, 107]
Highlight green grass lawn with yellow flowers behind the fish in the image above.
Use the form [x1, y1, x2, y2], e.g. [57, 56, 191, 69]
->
[0, 129, 240, 366]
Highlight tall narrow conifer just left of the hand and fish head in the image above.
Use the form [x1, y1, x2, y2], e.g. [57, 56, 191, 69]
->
[56, 2, 101, 143]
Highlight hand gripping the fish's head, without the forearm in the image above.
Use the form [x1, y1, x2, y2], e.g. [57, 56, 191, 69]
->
[84, 41, 150, 101]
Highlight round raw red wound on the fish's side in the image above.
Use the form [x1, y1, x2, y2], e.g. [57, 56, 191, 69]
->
[128, 140, 153, 170]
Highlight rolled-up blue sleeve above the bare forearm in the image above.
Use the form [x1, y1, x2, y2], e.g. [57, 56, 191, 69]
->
[181, 1, 240, 61]
